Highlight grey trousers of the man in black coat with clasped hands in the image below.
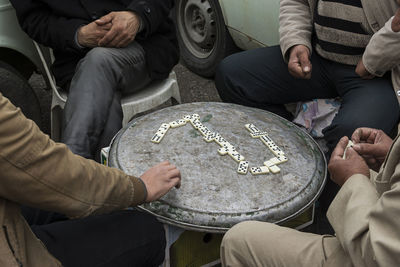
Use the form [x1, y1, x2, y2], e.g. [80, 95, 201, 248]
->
[61, 42, 150, 160]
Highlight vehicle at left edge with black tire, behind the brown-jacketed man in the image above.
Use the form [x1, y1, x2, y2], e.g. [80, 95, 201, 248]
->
[0, 0, 43, 125]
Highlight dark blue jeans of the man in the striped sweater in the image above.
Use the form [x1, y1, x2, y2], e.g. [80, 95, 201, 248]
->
[215, 46, 399, 211]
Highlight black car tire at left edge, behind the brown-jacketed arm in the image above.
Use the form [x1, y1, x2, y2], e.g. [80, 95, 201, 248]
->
[0, 61, 42, 127]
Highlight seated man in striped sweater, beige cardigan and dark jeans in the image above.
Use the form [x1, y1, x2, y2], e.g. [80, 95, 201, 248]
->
[215, 0, 400, 208]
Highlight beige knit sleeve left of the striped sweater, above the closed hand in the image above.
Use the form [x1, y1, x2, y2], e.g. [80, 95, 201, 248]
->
[279, 0, 313, 62]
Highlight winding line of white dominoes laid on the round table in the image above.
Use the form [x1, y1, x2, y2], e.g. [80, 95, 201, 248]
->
[151, 114, 288, 175]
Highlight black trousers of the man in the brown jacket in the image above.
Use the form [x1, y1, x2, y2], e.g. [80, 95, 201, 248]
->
[22, 207, 165, 267]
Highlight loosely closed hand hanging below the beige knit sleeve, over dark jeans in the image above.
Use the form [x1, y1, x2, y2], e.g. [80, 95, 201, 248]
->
[288, 45, 312, 79]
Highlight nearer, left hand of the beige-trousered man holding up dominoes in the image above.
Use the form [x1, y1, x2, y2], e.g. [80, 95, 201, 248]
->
[328, 136, 369, 186]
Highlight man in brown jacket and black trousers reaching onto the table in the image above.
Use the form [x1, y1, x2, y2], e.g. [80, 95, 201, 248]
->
[0, 94, 180, 267]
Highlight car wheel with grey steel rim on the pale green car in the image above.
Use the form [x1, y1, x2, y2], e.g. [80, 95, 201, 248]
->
[174, 0, 238, 77]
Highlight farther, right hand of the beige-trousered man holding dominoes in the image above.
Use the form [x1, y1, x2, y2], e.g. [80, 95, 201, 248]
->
[351, 128, 393, 172]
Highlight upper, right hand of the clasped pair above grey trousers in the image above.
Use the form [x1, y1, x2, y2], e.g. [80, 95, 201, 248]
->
[95, 11, 140, 47]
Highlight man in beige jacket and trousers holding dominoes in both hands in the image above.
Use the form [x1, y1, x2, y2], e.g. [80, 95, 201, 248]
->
[221, 125, 400, 267]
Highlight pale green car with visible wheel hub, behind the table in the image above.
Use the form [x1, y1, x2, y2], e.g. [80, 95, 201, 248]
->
[175, 0, 279, 77]
